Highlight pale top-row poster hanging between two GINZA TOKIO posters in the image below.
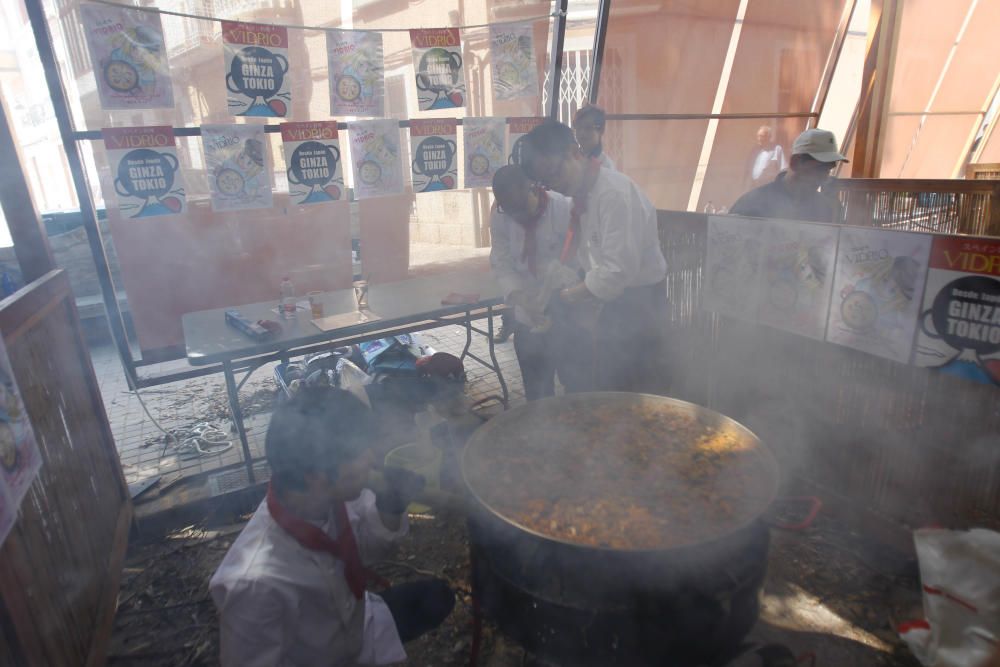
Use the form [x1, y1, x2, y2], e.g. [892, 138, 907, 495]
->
[326, 30, 385, 116]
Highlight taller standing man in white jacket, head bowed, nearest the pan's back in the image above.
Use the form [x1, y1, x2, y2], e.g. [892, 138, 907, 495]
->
[524, 122, 667, 391]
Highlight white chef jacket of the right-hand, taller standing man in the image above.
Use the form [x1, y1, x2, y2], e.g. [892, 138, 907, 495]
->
[578, 167, 667, 301]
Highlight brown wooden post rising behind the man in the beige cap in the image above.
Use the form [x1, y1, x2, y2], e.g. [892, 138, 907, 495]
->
[851, 0, 902, 178]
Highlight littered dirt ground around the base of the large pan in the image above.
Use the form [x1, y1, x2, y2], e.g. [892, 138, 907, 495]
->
[108, 510, 920, 667]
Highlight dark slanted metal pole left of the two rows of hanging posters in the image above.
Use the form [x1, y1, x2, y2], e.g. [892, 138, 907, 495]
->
[24, 0, 137, 389]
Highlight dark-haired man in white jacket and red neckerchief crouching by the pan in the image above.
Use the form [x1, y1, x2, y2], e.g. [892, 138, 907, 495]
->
[209, 387, 454, 667]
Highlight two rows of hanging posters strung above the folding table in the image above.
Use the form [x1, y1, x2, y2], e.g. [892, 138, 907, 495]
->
[80, 3, 541, 218]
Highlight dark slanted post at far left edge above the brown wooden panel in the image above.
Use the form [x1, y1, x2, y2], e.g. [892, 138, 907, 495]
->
[0, 100, 56, 284]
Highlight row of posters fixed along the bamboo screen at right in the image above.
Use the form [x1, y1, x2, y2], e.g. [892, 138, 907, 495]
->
[704, 216, 1000, 385]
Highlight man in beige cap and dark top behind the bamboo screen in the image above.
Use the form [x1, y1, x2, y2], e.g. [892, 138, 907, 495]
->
[729, 129, 847, 222]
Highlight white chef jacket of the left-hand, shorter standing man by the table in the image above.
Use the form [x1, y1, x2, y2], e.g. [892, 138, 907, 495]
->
[490, 192, 573, 326]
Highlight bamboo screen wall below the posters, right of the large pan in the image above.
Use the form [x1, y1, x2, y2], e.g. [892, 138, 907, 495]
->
[660, 211, 1000, 527]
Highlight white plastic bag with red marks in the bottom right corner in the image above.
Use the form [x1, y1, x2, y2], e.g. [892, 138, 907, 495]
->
[899, 529, 1000, 667]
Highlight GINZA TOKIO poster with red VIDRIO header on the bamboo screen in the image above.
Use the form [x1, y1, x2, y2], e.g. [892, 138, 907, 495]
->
[913, 236, 1000, 385]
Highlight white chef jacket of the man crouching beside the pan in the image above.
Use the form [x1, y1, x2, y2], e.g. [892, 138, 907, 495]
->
[209, 489, 409, 667]
